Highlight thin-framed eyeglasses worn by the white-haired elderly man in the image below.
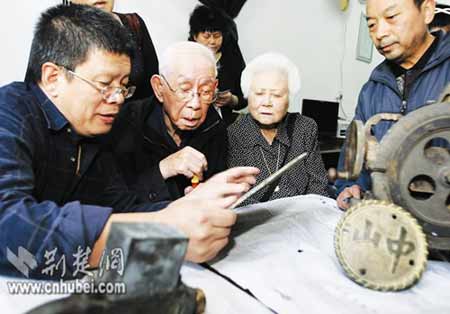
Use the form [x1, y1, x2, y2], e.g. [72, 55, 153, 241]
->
[160, 74, 217, 105]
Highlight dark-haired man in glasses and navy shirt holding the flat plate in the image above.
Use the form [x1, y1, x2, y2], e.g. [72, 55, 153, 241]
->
[0, 5, 258, 279]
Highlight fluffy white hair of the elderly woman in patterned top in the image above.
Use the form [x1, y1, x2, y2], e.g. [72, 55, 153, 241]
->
[241, 52, 301, 103]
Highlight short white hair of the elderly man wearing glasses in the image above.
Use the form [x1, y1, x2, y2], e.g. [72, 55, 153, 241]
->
[159, 41, 217, 77]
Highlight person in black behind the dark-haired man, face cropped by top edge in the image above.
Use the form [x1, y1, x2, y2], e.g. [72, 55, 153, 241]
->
[67, 0, 158, 101]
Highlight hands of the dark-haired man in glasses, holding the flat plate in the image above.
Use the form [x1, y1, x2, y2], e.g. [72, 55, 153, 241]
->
[160, 167, 259, 263]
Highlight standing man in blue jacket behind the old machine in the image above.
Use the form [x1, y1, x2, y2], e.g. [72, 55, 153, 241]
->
[336, 0, 450, 209]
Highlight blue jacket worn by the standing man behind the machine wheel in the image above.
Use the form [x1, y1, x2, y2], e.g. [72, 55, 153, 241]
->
[335, 33, 450, 194]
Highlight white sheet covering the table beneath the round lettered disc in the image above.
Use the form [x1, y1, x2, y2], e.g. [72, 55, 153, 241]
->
[208, 195, 450, 314]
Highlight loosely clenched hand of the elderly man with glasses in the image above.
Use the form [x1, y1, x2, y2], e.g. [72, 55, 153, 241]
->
[159, 146, 208, 180]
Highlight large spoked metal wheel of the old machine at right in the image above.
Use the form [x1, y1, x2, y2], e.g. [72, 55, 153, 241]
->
[371, 103, 450, 240]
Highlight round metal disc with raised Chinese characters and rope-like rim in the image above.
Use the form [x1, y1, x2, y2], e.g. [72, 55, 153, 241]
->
[334, 200, 428, 291]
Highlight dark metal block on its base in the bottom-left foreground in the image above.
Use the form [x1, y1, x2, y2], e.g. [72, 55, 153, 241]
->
[29, 223, 206, 314]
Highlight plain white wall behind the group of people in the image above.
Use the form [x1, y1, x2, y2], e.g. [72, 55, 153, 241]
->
[0, 0, 382, 118]
